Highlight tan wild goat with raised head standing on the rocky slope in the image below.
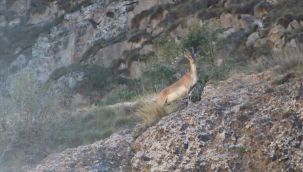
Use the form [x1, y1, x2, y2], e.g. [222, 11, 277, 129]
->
[156, 51, 198, 106]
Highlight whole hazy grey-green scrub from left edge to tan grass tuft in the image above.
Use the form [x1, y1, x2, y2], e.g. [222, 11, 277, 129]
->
[0, 69, 136, 171]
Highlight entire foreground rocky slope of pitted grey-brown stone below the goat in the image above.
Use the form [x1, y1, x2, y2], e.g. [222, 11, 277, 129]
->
[33, 71, 303, 172]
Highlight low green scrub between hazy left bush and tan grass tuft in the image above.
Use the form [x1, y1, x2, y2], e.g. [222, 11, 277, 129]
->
[54, 106, 136, 148]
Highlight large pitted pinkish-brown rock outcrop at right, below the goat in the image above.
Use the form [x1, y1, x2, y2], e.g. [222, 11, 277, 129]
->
[132, 72, 303, 171]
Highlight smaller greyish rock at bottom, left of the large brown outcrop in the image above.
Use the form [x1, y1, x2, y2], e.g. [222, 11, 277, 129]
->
[30, 132, 132, 172]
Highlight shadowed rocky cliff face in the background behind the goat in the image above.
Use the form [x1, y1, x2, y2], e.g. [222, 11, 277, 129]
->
[0, 0, 303, 96]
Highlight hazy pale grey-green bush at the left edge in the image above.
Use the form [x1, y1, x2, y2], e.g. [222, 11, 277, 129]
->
[0, 72, 64, 171]
